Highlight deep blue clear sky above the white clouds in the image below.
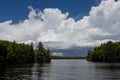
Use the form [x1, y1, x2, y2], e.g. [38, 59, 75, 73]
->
[0, 0, 101, 23]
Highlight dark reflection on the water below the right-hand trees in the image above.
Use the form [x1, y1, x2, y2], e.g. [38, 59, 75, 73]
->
[95, 63, 120, 80]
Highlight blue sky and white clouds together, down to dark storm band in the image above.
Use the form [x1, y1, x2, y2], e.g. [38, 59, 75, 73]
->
[0, 0, 120, 49]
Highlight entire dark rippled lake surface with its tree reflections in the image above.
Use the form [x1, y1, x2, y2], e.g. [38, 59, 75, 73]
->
[0, 59, 120, 80]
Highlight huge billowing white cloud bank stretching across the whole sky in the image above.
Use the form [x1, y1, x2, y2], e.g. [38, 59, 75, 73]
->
[0, 0, 120, 49]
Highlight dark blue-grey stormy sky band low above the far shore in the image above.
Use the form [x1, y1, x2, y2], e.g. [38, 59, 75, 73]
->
[51, 47, 94, 57]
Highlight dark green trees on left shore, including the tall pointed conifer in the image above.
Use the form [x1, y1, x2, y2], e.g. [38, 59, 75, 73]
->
[0, 40, 50, 64]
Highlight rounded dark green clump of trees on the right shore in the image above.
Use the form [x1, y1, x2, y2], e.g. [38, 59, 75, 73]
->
[87, 41, 120, 62]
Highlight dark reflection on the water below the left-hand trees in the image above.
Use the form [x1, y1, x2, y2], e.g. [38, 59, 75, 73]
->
[0, 63, 49, 80]
